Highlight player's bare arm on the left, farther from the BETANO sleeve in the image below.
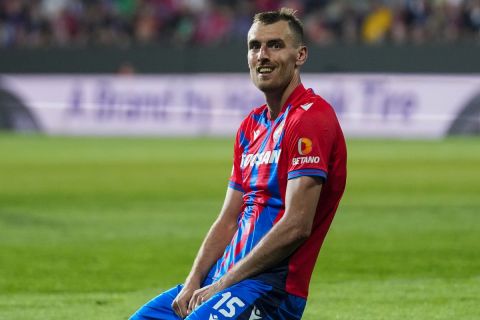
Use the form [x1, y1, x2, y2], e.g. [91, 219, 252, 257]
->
[172, 188, 243, 318]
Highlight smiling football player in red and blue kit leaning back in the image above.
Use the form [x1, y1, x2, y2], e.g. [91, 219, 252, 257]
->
[131, 8, 346, 320]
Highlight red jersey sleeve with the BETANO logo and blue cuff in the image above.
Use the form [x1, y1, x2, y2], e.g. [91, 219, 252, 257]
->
[284, 104, 336, 181]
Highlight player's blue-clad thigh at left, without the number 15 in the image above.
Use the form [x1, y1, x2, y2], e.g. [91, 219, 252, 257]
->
[130, 285, 183, 320]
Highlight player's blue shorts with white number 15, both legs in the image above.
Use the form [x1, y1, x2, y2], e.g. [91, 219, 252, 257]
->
[130, 279, 306, 320]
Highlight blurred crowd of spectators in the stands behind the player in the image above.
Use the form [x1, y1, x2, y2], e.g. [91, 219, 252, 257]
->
[0, 0, 480, 47]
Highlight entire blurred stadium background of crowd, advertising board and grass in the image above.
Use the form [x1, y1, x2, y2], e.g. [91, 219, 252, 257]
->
[0, 0, 480, 320]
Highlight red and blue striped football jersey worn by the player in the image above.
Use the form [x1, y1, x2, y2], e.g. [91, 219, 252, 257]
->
[209, 84, 346, 298]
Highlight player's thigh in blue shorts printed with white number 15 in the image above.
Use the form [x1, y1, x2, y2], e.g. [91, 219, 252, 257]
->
[186, 279, 305, 320]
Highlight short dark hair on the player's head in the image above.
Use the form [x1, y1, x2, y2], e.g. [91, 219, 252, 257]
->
[253, 8, 305, 45]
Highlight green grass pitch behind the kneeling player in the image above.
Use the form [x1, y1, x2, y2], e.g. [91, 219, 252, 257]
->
[0, 134, 480, 320]
